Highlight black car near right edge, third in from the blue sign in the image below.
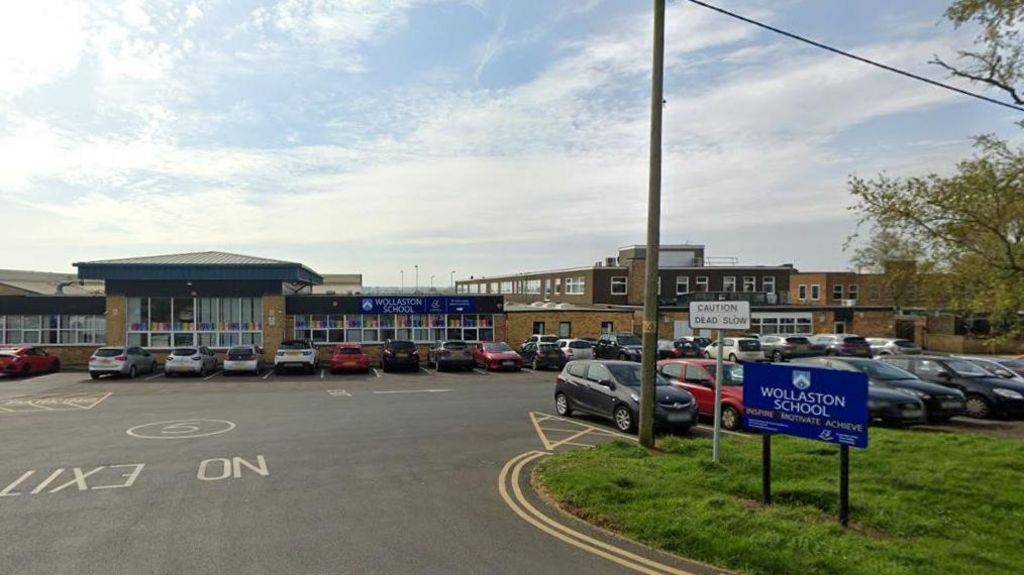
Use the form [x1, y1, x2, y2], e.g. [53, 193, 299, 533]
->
[881, 355, 1024, 418]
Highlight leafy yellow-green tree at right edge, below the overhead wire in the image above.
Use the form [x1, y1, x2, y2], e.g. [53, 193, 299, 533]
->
[850, 136, 1024, 335]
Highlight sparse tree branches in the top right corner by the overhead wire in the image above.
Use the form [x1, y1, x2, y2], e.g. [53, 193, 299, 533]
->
[931, 0, 1024, 104]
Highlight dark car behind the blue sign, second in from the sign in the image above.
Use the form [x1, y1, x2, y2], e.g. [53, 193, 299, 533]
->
[802, 357, 967, 422]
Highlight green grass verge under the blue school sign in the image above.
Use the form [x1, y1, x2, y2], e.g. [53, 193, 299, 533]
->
[537, 430, 1024, 575]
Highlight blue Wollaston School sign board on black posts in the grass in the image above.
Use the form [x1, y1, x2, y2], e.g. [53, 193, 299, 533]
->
[743, 363, 870, 448]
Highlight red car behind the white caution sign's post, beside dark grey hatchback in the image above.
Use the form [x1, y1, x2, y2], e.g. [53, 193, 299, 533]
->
[657, 359, 743, 431]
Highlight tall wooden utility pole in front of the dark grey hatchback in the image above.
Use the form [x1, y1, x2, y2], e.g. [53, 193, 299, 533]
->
[639, 0, 666, 447]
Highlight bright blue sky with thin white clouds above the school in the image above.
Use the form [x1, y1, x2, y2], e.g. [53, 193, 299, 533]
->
[0, 0, 1019, 286]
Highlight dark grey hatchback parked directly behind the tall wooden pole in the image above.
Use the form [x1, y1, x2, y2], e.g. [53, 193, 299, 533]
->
[555, 359, 697, 433]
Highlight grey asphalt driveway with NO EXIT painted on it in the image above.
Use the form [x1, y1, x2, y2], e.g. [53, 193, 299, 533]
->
[0, 371, 692, 574]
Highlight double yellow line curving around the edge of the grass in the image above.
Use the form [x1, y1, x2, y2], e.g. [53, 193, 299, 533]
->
[498, 451, 695, 575]
